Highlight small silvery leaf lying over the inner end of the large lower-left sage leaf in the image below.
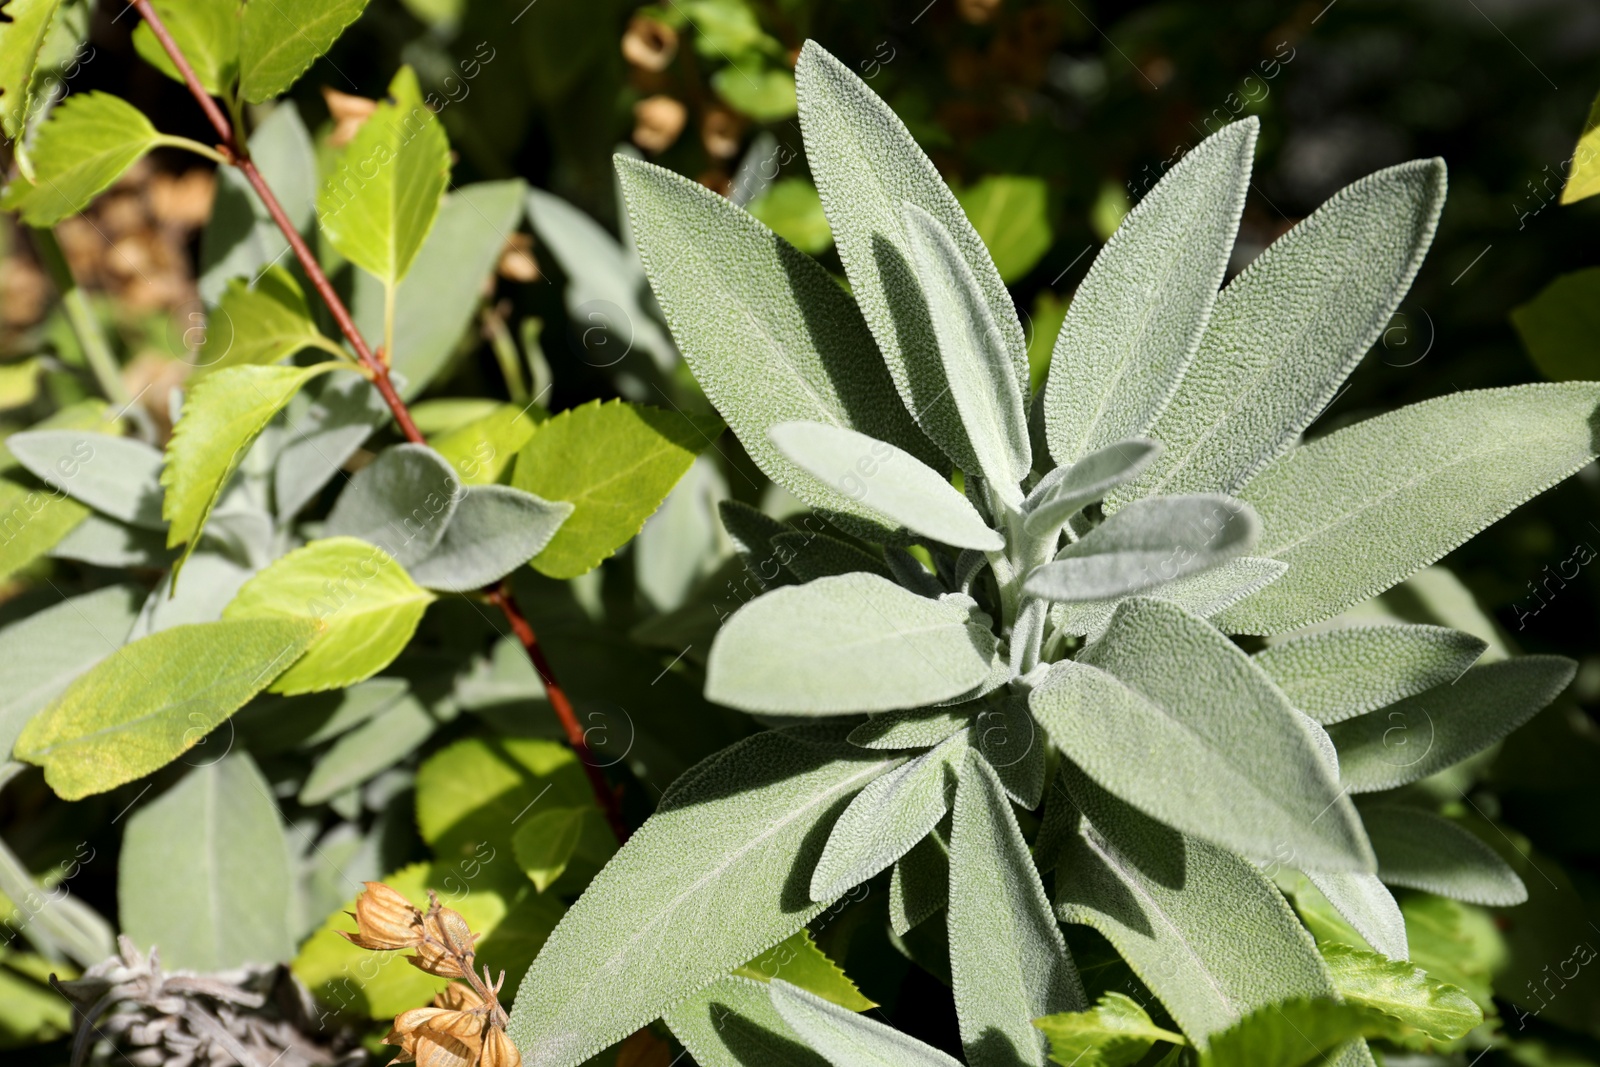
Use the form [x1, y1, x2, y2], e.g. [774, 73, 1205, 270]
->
[811, 734, 966, 901]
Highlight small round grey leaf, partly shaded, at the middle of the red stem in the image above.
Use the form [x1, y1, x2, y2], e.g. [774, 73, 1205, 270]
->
[323, 443, 462, 566]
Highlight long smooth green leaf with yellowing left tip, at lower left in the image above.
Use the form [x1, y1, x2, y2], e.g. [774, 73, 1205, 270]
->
[16, 619, 318, 800]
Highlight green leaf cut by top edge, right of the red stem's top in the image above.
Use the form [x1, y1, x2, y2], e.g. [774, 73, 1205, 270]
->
[238, 0, 366, 104]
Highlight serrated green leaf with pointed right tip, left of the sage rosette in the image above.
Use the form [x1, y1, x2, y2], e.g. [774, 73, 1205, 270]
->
[512, 400, 722, 577]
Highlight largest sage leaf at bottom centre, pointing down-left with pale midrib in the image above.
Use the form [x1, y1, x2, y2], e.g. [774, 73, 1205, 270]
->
[510, 729, 898, 1067]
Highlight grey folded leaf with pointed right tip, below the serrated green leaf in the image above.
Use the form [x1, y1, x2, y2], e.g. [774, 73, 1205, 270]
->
[411, 485, 573, 593]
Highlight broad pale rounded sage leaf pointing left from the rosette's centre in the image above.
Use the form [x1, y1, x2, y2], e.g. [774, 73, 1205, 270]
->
[706, 574, 995, 715]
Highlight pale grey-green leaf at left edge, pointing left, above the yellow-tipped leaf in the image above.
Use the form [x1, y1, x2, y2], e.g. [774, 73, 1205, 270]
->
[5, 430, 166, 530]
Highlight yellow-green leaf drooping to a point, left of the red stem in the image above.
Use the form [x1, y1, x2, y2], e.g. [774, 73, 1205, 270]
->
[162, 363, 339, 577]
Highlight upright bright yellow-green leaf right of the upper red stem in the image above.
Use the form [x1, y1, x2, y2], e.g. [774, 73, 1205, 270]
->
[315, 64, 450, 286]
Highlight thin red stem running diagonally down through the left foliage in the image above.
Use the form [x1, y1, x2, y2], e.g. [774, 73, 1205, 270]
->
[133, 0, 629, 843]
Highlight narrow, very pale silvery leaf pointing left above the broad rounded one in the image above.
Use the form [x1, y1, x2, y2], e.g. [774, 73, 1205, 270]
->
[766, 422, 1005, 552]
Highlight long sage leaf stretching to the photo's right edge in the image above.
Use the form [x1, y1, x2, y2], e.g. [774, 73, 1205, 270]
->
[1218, 382, 1600, 633]
